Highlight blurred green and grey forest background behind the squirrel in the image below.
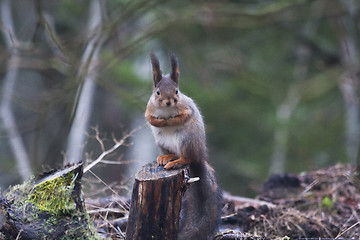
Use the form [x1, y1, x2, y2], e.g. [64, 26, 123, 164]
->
[0, 0, 360, 196]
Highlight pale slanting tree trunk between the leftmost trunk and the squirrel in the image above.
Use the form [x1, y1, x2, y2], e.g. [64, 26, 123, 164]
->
[66, 0, 105, 163]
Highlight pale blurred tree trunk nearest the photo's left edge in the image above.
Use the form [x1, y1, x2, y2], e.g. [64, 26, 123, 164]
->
[0, 0, 32, 180]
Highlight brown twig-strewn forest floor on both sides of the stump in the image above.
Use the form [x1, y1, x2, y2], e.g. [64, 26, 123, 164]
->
[89, 165, 360, 240]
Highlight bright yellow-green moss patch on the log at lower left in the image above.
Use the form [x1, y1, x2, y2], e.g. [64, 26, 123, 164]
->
[26, 173, 76, 215]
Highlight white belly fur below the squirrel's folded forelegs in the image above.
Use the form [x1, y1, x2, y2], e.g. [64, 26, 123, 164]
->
[152, 127, 181, 155]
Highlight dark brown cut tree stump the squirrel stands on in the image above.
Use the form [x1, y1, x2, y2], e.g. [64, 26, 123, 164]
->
[126, 162, 189, 240]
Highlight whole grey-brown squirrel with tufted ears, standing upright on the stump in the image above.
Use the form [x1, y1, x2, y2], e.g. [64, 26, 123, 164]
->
[145, 53, 222, 240]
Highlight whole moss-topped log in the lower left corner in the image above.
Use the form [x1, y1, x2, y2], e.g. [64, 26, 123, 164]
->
[0, 164, 100, 240]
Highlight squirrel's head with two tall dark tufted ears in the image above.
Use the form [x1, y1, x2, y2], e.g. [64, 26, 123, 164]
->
[150, 53, 180, 107]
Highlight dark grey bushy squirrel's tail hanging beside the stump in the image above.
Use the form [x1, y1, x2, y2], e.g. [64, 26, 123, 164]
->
[178, 161, 222, 240]
